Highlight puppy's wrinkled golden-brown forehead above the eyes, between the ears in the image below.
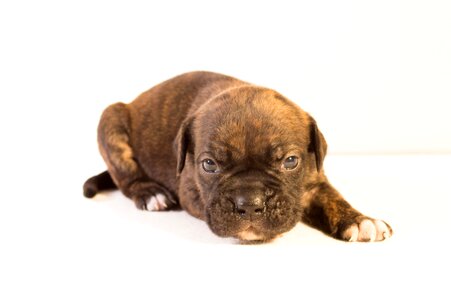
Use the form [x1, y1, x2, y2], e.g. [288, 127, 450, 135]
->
[196, 87, 308, 160]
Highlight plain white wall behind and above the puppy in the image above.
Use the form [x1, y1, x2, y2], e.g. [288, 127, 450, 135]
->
[0, 0, 451, 153]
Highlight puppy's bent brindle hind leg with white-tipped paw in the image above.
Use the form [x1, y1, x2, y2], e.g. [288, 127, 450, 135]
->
[97, 103, 177, 211]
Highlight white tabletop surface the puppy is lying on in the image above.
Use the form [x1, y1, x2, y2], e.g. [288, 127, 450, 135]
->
[0, 156, 451, 299]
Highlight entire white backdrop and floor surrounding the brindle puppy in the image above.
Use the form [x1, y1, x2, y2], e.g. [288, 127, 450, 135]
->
[0, 0, 451, 299]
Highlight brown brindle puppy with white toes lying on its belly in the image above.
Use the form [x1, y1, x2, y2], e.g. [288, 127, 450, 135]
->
[84, 72, 392, 241]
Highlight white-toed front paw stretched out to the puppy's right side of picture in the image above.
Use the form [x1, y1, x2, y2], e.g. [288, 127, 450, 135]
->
[341, 217, 393, 242]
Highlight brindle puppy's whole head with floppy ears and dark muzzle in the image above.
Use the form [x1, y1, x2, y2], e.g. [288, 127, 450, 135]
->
[177, 86, 327, 241]
